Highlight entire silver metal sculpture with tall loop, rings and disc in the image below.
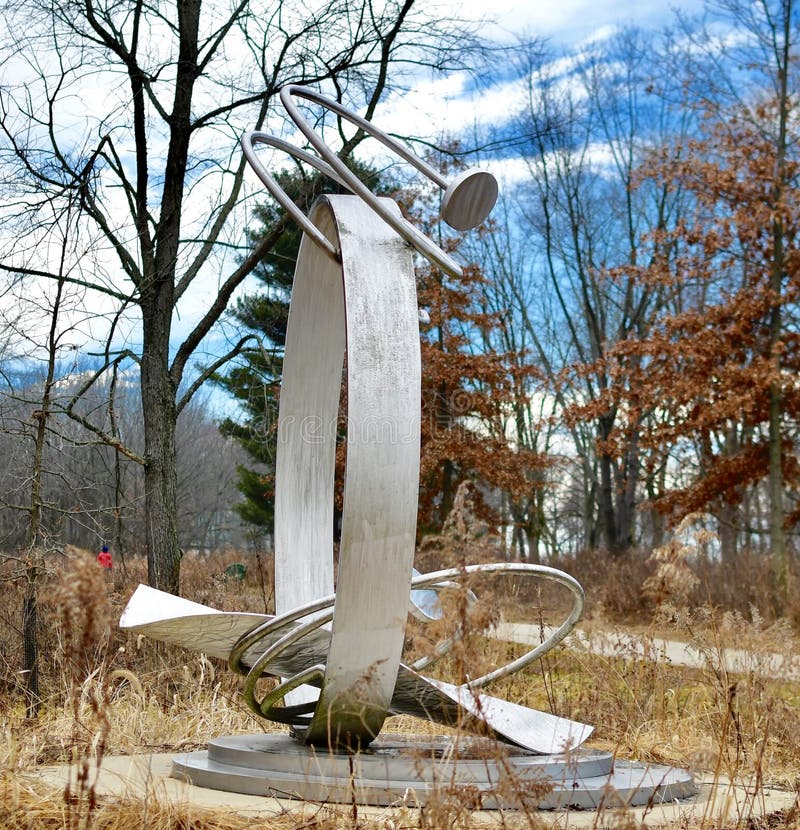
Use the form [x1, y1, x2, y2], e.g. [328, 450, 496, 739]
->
[120, 86, 692, 812]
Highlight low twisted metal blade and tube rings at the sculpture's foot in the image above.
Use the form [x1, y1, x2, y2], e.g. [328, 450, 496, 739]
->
[120, 563, 592, 753]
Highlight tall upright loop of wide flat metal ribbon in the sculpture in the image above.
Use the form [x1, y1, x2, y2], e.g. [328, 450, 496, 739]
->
[275, 196, 421, 745]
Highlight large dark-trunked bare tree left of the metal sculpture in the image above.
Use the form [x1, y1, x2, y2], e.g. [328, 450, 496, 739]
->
[0, 0, 482, 591]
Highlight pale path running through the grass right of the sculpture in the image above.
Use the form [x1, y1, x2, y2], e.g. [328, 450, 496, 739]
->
[495, 623, 800, 681]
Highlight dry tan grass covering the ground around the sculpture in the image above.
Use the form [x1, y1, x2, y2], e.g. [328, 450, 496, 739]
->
[0, 545, 800, 830]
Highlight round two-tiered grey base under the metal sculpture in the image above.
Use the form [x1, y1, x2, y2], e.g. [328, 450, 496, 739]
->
[172, 735, 697, 810]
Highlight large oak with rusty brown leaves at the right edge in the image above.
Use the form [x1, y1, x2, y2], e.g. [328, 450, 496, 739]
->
[596, 98, 800, 582]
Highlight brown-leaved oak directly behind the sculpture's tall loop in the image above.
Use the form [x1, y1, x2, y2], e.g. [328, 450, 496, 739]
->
[417, 159, 546, 553]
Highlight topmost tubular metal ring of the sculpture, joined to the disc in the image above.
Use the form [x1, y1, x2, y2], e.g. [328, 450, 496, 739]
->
[280, 84, 462, 277]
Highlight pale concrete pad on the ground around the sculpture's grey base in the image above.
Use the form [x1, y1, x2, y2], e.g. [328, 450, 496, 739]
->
[28, 753, 796, 830]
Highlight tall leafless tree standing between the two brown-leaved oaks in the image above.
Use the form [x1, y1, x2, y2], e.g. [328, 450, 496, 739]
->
[509, 31, 686, 553]
